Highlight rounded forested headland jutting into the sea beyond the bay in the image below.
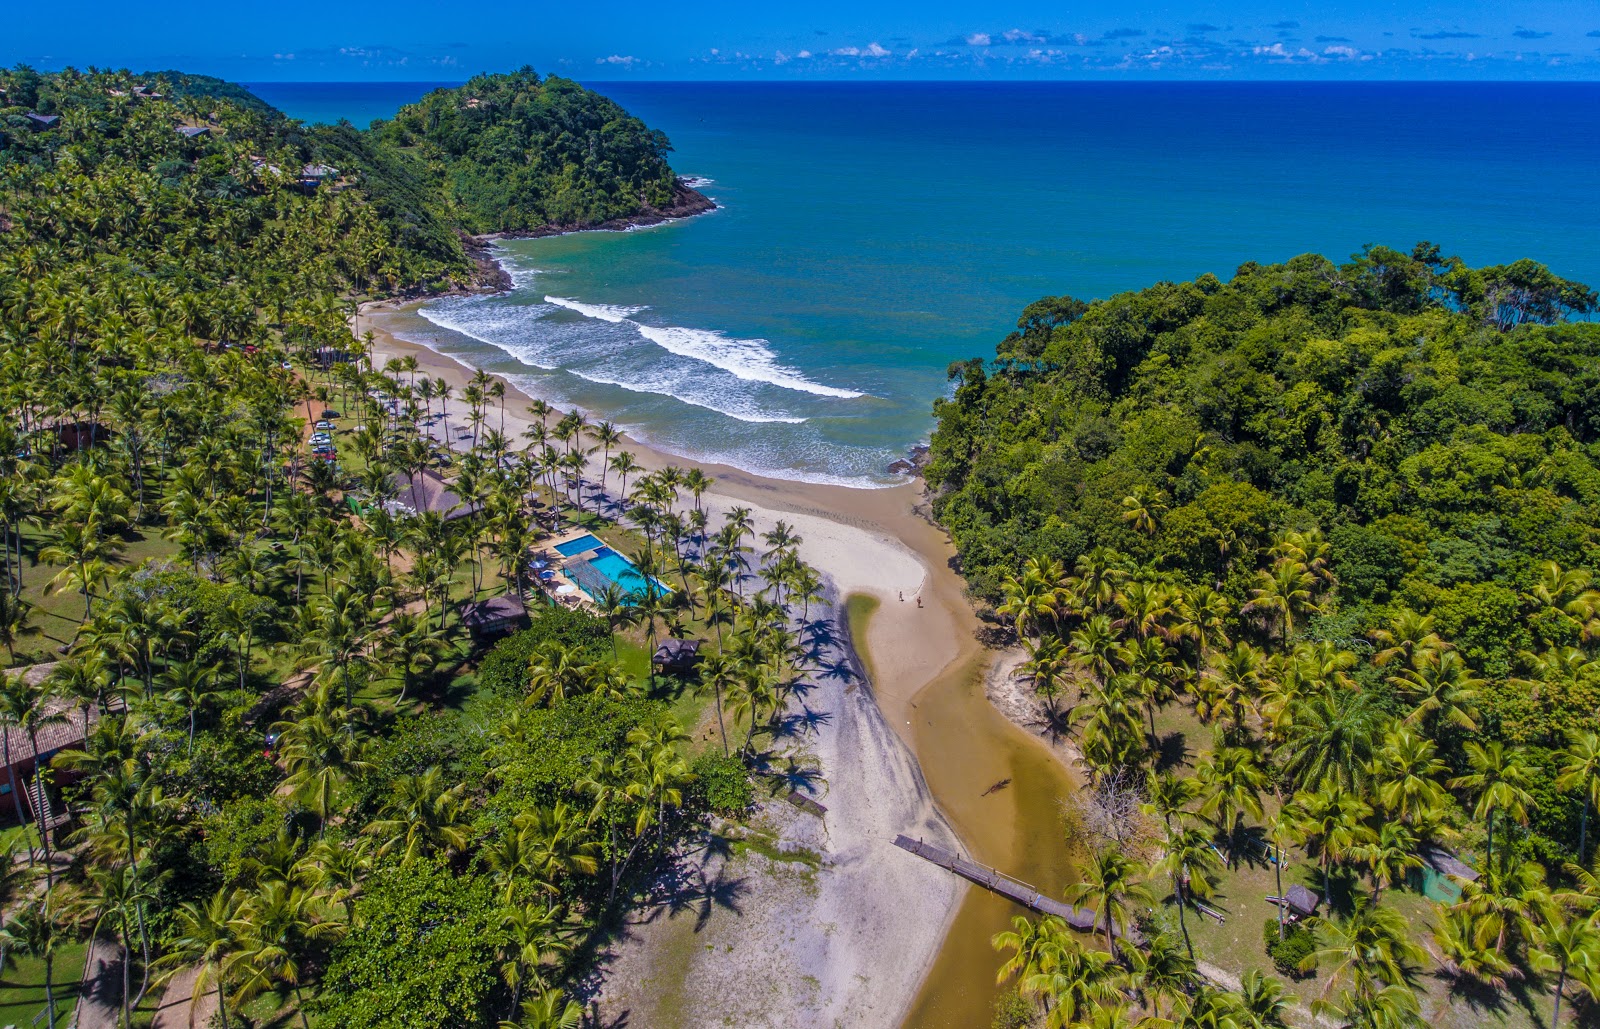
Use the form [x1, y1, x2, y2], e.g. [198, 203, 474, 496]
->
[374, 69, 710, 234]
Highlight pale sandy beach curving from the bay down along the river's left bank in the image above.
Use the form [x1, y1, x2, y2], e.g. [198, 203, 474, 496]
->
[358, 306, 978, 1029]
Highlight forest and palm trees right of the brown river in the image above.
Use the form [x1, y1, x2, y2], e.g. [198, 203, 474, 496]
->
[928, 245, 1600, 1029]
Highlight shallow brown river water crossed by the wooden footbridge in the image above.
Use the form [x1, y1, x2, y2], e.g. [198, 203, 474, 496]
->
[883, 648, 1077, 1029]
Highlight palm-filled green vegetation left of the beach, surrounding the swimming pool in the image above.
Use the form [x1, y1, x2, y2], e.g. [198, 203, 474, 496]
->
[0, 62, 800, 1029]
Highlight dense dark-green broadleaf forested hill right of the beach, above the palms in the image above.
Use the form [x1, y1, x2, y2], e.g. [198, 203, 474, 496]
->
[926, 245, 1600, 675]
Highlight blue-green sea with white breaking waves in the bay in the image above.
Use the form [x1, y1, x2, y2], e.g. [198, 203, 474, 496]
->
[243, 83, 1600, 485]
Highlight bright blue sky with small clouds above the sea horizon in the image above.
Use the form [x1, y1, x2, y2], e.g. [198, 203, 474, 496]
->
[12, 0, 1600, 82]
